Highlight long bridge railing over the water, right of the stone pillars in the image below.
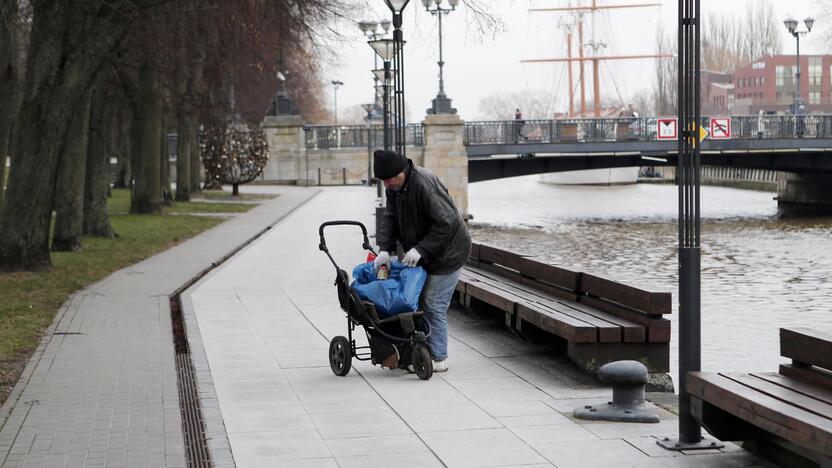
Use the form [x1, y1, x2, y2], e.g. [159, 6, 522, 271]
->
[464, 115, 832, 145]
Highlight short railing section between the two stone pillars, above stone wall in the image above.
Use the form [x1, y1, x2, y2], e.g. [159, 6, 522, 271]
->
[303, 124, 424, 149]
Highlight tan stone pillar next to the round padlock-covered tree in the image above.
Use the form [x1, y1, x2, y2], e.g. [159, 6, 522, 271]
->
[262, 115, 314, 185]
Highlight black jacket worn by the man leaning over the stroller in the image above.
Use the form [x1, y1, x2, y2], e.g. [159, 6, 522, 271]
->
[378, 159, 471, 275]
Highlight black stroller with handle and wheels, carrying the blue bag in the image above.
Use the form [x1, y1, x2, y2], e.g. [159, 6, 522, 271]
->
[318, 221, 433, 380]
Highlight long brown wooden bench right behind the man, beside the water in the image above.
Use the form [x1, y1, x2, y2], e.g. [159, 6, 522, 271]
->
[457, 244, 671, 372]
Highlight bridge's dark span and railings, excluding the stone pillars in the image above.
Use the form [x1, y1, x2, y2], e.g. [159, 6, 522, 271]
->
[306, 115, 832, 182]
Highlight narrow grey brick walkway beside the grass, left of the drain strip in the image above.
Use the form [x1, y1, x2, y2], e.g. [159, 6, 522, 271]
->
[0, 187, 317, 467]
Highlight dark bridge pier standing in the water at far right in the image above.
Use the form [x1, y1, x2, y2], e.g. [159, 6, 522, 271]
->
[777, 172, 832, 215]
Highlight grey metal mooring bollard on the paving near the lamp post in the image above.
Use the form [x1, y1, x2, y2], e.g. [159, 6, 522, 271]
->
[573, 361, 659, 423]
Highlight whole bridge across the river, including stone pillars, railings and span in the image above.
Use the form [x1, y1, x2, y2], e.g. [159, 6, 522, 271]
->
[264, 115, 832, 216]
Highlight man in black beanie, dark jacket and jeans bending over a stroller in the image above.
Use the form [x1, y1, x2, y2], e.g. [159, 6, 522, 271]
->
[373, 150, 471, 372]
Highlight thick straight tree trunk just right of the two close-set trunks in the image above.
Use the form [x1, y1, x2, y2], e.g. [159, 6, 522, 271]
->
[130, 57, 162, 214]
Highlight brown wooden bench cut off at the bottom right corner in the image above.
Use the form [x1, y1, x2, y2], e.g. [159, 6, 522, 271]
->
[687, 328, 832, 467]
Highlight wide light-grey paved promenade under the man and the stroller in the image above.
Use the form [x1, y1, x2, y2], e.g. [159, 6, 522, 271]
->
[188, 187, 770, 468]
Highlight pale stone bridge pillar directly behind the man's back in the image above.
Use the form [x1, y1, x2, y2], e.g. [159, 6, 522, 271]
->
[422, 114, 468, 219]
